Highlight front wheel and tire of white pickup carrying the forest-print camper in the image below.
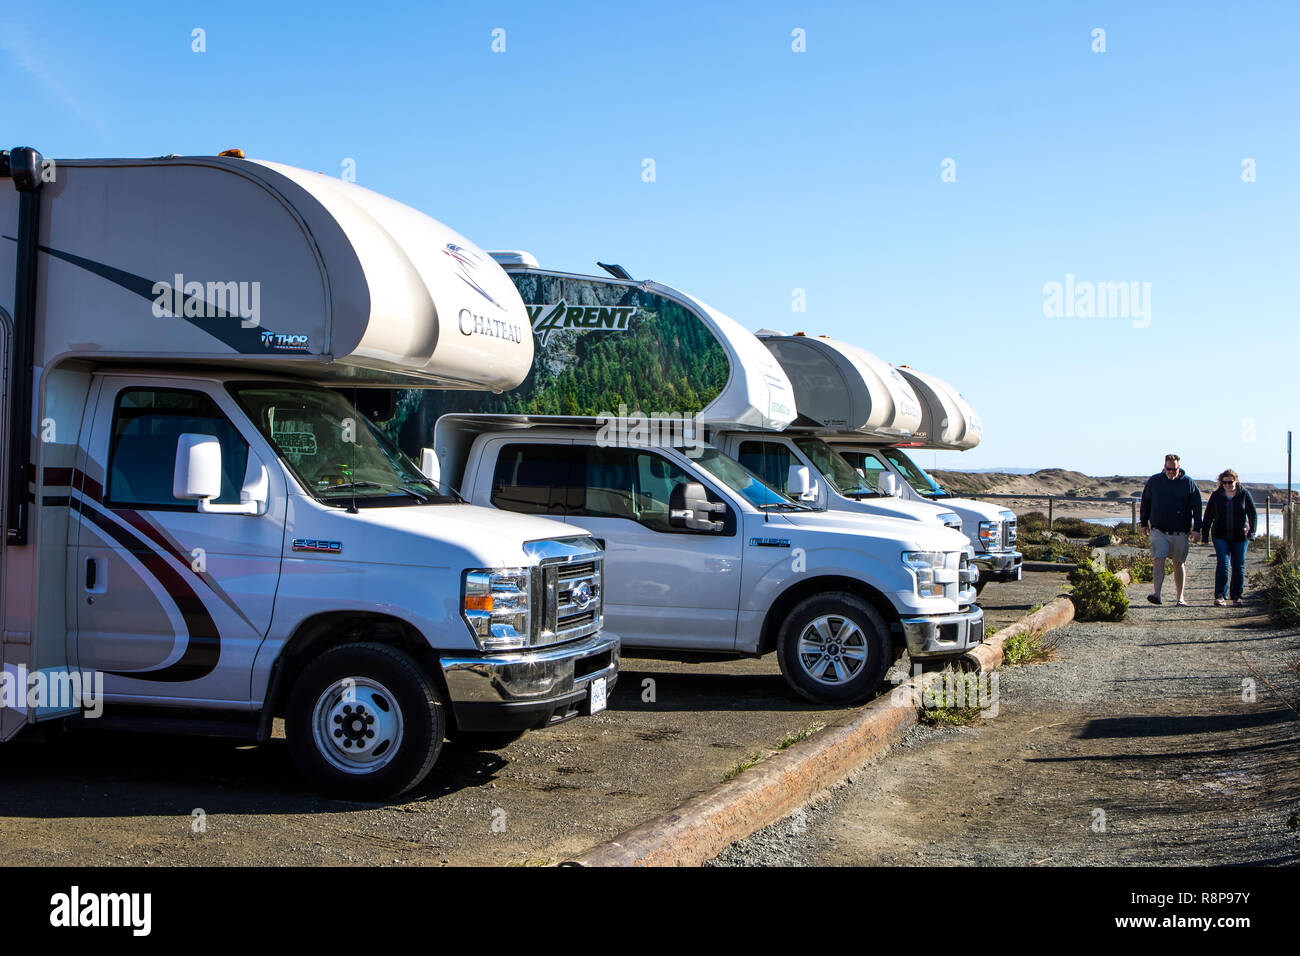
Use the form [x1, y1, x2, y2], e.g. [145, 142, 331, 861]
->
[776, 591, 894, 705]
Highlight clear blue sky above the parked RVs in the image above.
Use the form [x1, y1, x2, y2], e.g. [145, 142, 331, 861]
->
[0, 3, 1300, 480]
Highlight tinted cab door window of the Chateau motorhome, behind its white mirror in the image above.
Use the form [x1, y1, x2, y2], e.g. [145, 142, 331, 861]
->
[107, 388, 248, 511]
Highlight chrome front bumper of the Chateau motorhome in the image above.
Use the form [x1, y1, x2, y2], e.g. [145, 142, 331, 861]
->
[441, 631, 619, 731]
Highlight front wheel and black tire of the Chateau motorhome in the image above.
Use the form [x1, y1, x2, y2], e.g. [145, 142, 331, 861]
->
[285, 643, 446, 800]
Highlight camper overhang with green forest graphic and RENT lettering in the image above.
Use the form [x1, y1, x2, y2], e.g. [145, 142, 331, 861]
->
[386, 265, 794, 450]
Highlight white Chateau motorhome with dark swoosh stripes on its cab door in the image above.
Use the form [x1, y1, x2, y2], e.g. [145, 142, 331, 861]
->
[0, 148, 619, 797]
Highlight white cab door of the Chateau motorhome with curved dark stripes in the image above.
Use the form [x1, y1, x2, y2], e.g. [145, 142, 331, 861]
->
[70, 376, 287, 708]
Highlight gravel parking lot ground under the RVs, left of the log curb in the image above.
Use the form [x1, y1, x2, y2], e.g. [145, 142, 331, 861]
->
[0, 574, 1063, 866]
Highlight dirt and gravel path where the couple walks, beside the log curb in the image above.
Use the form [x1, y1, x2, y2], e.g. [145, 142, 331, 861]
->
[716, 549, 1300, 865]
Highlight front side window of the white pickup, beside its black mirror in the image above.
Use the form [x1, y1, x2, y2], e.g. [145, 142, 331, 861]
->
[575, 446, 722, 535]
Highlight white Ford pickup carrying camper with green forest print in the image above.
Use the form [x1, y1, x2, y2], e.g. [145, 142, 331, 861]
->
[398, 254, 984, 702]
